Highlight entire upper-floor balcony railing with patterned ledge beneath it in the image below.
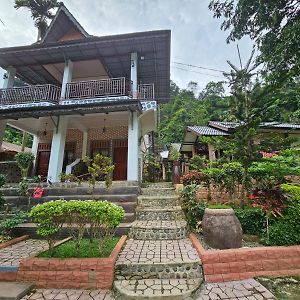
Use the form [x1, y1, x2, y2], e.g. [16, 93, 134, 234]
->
[0, 77, 154, 109]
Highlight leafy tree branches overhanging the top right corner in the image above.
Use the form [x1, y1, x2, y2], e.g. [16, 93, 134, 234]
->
[209, 0, 300, 82]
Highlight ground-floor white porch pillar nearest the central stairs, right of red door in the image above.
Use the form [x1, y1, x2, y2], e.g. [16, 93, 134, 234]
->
[127, 112, 139, 181]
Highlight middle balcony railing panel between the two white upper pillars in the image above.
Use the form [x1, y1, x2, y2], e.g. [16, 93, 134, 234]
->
[65, 77, 128, 99]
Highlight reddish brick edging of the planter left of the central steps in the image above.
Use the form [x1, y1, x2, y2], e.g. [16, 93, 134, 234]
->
[17, 235, 127, 289]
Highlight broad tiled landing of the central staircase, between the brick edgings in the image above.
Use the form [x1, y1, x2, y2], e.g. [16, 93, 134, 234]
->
[117, 239, 199, 264]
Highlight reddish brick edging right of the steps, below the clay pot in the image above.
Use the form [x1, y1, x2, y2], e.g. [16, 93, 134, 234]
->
[189, 233, 300, 282]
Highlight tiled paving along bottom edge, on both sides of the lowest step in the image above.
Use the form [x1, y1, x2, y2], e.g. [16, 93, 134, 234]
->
[22, 279, 275, 300]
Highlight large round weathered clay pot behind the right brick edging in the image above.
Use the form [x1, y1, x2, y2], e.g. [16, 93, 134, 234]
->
[202, 208, 243, 249]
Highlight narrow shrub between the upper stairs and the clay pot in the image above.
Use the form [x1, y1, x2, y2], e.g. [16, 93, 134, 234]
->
[180, 184, 206, 230]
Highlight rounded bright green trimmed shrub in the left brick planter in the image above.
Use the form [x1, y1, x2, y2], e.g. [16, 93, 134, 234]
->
[30, 200, 125, 254]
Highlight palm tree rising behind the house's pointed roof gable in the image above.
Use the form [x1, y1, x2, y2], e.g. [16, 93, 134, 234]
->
[14, 0, 60, 41]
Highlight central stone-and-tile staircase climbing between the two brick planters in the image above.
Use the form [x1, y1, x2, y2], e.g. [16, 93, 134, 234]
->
[114, 183, 203, 300]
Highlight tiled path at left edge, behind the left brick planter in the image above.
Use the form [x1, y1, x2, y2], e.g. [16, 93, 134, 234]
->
[0, 239, 48, 266]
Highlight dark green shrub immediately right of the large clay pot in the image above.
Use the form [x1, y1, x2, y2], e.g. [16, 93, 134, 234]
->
[234, 207, 266, 235]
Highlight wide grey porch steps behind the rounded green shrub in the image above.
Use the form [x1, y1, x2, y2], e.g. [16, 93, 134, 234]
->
[0, 182, 140, 237]
